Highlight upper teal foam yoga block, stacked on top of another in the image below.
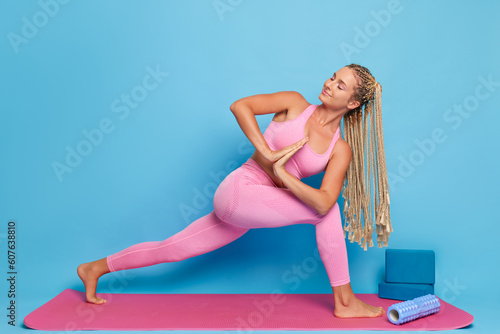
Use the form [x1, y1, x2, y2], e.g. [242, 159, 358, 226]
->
[385, 249, 436, 284]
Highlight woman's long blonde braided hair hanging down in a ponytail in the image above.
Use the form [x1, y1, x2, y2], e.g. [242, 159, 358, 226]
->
[341, 64, 393, 250]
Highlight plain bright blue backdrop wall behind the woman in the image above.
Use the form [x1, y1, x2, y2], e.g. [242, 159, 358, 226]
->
[0, 0, 500, 332]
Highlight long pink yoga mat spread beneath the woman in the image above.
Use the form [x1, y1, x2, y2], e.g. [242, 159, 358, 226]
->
[24, 289, 474, 333]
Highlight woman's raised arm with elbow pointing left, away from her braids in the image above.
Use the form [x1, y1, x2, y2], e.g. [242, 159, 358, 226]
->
[230, 91, 309, 162]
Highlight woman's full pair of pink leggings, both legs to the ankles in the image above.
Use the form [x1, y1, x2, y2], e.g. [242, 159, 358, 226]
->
[106, 159, 350, 286]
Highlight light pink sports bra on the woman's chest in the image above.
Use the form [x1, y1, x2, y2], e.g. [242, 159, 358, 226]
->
[263, 104, 340, 180]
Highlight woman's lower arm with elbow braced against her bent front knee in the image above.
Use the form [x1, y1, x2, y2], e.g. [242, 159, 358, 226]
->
[273, 140, 352, 216]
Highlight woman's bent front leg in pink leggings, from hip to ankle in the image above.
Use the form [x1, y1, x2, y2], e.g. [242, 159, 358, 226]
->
[214, 159, 350, 287]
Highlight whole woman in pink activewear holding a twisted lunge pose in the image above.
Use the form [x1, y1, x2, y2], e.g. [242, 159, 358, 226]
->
[77, 64, 392, 318]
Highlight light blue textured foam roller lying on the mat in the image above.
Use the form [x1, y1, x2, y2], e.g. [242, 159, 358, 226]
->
[387, 295, 441, 325]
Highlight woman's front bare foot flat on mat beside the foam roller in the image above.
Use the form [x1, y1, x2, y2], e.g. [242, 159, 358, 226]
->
[333, 283, 385, 318]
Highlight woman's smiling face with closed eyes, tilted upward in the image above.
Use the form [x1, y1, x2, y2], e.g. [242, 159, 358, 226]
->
[319, 67, 359, 112]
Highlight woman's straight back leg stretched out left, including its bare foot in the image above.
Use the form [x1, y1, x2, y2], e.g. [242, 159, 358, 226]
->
[77, 211, 248, 304]
